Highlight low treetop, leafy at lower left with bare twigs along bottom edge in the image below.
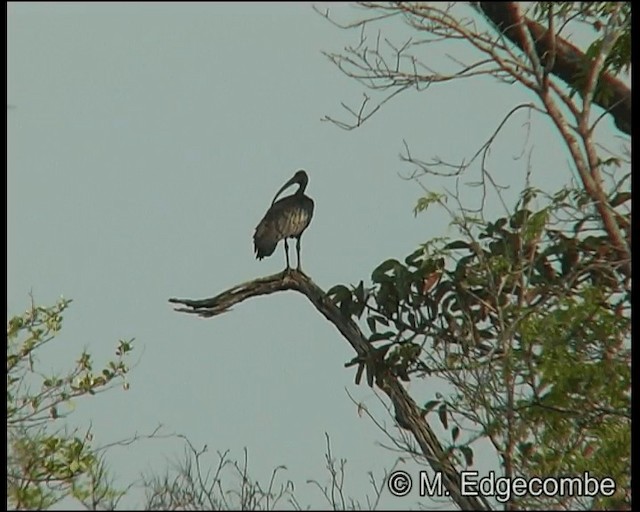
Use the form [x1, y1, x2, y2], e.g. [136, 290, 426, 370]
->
[7, 299, 383, 510]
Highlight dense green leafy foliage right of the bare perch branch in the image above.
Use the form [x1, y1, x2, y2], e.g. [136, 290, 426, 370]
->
[328, 189, 631, 506]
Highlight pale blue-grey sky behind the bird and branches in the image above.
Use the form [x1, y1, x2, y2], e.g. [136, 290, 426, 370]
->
[7, 3, 624, 508]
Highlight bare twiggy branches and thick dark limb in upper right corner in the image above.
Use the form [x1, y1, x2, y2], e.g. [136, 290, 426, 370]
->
[324, 2, 631, 274]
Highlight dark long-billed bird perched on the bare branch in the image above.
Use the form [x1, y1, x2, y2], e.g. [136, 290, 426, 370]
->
[253, 169, 313, 271]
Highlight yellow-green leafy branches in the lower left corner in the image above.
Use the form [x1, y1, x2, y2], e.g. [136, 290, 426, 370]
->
[7, 299, 132, 509]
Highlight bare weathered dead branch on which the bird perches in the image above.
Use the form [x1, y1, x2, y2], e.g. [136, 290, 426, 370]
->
[169, 270, 491, 510]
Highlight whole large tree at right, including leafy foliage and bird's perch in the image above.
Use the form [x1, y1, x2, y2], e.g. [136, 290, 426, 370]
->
[171, 2, 631, 509]
